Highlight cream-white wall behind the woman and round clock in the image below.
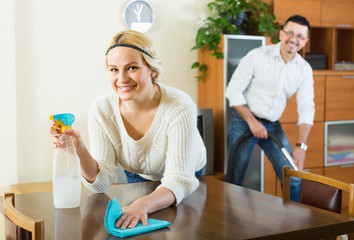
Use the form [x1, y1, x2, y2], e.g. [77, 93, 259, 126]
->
[0, 0, 208, 187]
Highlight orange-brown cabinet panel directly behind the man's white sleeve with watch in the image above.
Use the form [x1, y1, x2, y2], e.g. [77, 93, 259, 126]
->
[280, 76, 325, 123]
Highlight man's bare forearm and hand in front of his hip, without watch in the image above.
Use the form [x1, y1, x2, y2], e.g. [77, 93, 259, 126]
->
[234, 105, 268, 138]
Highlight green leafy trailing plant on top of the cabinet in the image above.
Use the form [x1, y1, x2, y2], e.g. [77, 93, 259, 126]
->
[191, 0, 280, 82]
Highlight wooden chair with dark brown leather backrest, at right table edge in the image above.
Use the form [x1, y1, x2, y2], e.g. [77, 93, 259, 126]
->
[282, 166, 354, 239]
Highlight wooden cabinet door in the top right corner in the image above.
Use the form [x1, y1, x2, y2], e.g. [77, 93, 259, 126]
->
[321, 0, 354, 27]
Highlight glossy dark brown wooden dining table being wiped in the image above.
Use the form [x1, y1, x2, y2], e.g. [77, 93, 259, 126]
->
[0, 177, 354, 240]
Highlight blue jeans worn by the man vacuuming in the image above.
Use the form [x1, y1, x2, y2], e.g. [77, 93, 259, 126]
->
[228, 109, 301, 202]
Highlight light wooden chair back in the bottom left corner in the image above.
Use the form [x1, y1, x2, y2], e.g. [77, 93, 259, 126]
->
[3, 193, 44, 240]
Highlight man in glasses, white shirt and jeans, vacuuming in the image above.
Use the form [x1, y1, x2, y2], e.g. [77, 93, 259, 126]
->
[225, 15, 315, 201]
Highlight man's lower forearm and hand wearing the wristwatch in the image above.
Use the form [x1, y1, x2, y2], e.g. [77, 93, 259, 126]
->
[292, 124, 312, 170]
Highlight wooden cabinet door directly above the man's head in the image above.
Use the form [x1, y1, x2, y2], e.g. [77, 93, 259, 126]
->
[274, 0, 321, 26]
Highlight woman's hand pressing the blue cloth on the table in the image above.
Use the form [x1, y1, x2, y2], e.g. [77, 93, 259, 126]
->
[116, 199, 148, 229]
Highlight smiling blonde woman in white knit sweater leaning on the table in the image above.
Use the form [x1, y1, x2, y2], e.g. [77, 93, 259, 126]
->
[50, 31, 206, 229]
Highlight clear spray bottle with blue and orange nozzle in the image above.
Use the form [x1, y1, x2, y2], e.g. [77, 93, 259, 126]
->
[49, 113, 81, 208]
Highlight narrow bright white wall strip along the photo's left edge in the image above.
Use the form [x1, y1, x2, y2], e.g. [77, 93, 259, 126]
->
[0, 0, 17, 189]
